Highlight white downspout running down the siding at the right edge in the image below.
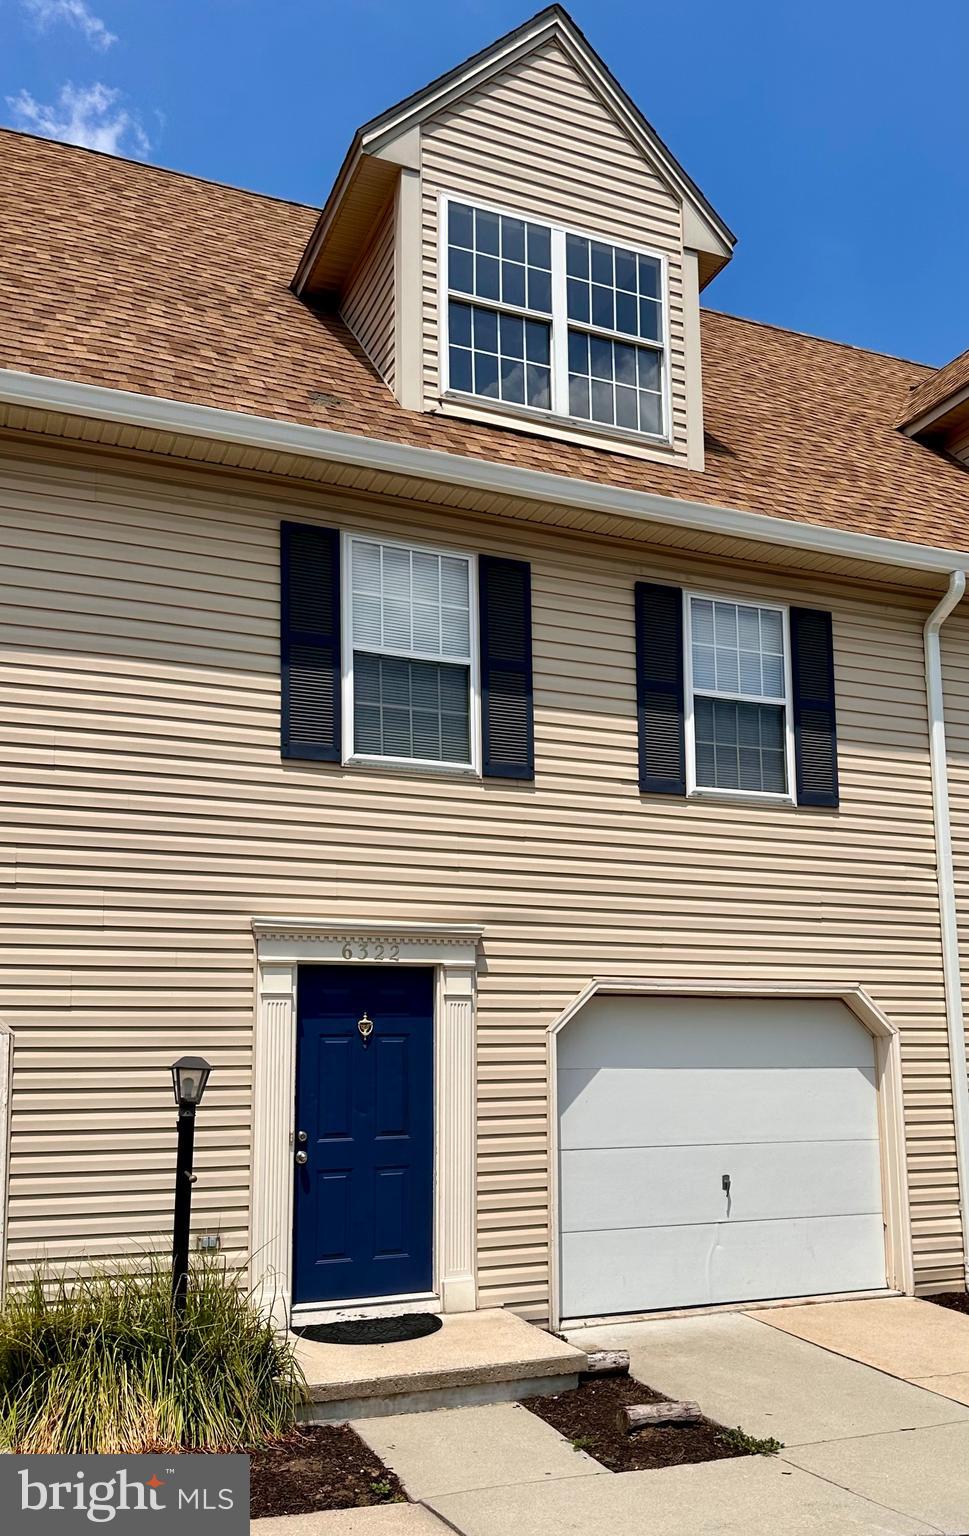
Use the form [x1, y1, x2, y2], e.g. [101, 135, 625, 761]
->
[923, 571, 969, 1283]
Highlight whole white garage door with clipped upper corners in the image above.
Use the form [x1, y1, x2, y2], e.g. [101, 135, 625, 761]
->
[557, 997, 885, 1318]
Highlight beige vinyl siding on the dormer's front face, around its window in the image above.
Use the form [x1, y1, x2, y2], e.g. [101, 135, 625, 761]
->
[421, 43, 686, 455]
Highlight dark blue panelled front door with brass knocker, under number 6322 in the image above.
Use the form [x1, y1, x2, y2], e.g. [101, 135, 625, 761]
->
[293, 963, 435, 1303]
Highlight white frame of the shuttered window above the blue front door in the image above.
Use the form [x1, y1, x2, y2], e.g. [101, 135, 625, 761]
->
[339, 528, 481, 777]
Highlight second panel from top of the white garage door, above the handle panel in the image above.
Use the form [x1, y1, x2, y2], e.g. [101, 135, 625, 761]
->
[559, 1069, 875, 1149]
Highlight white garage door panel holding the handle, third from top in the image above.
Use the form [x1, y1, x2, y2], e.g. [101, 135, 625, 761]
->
[562, 1141, 881, 1232]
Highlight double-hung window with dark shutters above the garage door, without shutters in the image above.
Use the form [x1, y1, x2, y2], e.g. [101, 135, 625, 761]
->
[686, 594, 792, 799]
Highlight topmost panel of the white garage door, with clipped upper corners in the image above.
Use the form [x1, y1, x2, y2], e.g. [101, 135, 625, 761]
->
[559, 997, 871, 1072]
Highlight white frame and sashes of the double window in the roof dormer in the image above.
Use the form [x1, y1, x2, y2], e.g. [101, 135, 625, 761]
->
[438, 192, 673, 447]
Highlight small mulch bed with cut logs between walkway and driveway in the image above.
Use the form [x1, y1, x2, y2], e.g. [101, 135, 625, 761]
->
[522, 1376, 748, 1471]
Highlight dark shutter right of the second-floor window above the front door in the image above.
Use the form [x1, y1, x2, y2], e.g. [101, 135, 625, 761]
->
[478, 554, 534, 779]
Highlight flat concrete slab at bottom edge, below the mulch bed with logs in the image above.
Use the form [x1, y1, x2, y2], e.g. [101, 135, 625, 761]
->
[430, 1456, 932, 1536]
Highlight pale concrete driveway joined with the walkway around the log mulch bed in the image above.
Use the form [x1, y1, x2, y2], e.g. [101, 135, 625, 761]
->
[255, 1298, 969, 1536]
